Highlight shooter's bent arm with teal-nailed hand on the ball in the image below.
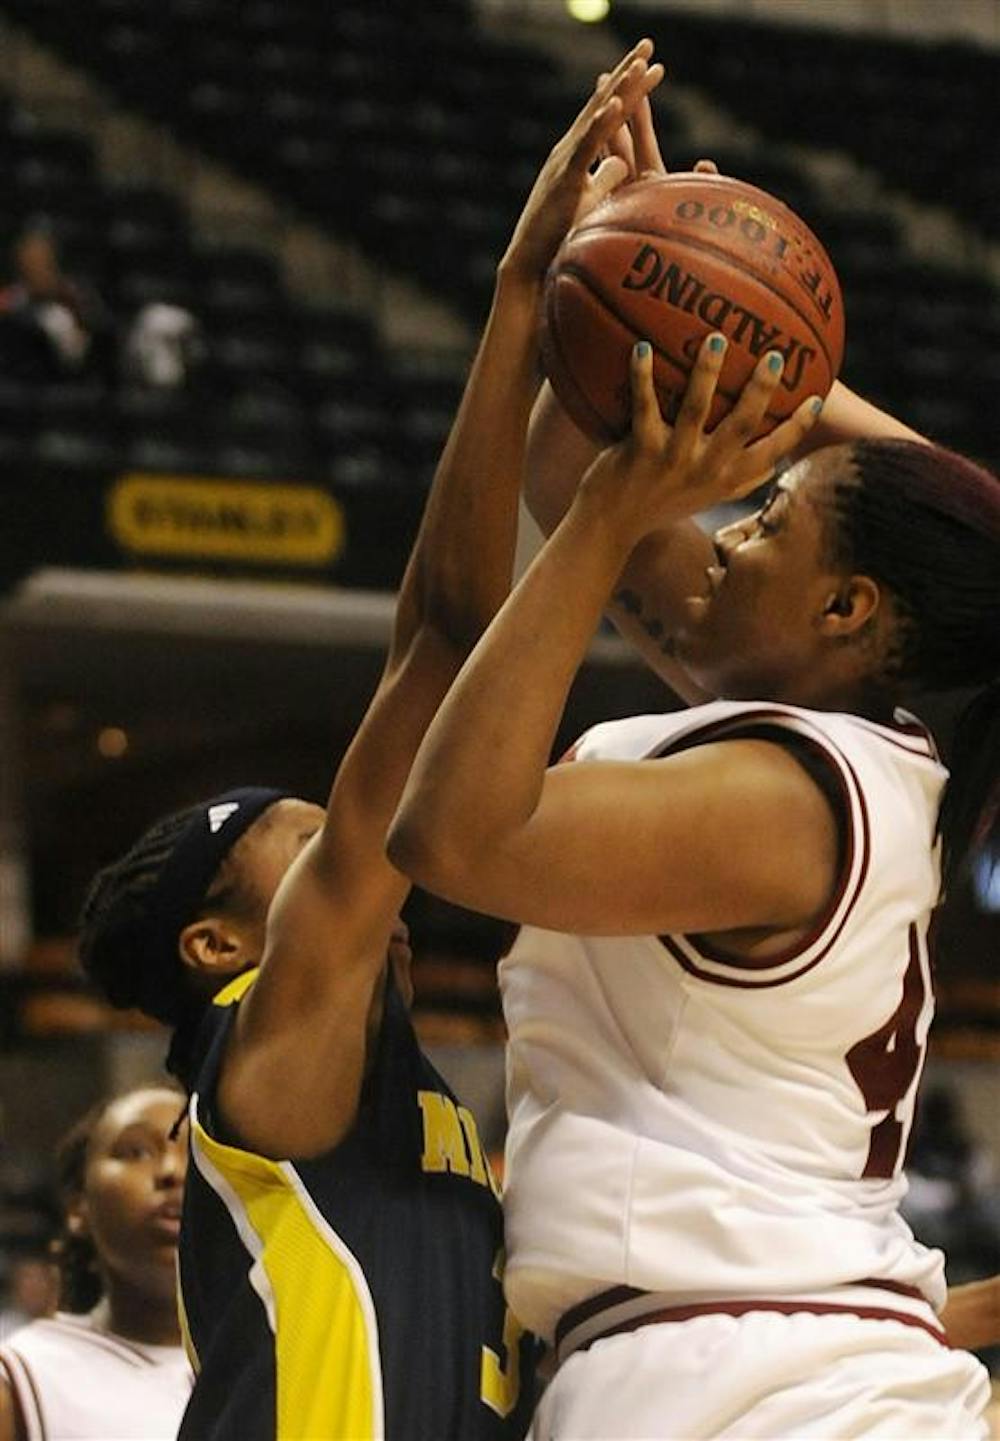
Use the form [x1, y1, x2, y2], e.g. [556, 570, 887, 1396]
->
[389, 337, 836, 935]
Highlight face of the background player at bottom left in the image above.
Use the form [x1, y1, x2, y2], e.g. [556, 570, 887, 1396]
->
[71, 1088, 187, 1301]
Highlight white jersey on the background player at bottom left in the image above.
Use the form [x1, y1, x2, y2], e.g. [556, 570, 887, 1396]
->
[0, 1311, 192, 1441]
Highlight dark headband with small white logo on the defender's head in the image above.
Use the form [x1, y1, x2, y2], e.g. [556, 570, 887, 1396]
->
[150, 785, 290, 950]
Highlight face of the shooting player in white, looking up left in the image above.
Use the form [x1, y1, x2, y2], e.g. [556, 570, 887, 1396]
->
[677, 447, 847, 703]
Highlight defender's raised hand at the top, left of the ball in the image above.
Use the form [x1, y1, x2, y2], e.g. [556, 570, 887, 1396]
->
[500, 40, 663, 284]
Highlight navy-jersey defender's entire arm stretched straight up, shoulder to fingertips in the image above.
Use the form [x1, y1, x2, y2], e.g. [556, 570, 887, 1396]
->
[219, 42, 661, 1156]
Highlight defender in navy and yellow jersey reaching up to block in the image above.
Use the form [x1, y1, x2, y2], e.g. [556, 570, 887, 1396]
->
[70, 42, 661, 1441]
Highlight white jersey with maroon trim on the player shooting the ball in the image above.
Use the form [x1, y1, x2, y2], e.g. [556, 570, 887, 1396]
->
[500, 702, 947, 1337]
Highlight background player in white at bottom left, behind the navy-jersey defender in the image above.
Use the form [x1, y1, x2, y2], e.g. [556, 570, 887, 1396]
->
[0, 1085, 193, 1441]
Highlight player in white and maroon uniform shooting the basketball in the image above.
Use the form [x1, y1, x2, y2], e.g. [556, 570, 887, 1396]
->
[390, 149, 1000, 1441]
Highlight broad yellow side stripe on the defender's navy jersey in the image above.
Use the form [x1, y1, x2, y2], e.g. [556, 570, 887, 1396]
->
[192, 1123, 383, 1441]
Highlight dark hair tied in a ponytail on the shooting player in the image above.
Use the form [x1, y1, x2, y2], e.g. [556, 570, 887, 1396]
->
[833, 440, 1000, 889]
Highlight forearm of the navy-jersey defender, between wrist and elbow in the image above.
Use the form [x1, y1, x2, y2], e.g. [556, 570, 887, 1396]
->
[393, 272, 537, 656]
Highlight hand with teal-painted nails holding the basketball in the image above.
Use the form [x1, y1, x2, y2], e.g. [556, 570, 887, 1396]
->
[581, 333, 823, 549]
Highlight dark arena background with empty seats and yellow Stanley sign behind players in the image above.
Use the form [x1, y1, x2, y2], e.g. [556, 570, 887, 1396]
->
[0, 0, 1000, 1394]
